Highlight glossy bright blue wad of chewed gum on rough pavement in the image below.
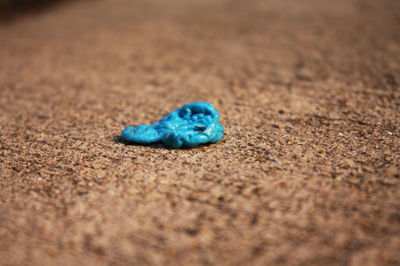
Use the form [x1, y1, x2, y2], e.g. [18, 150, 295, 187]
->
[122, 102, 224, 148]
